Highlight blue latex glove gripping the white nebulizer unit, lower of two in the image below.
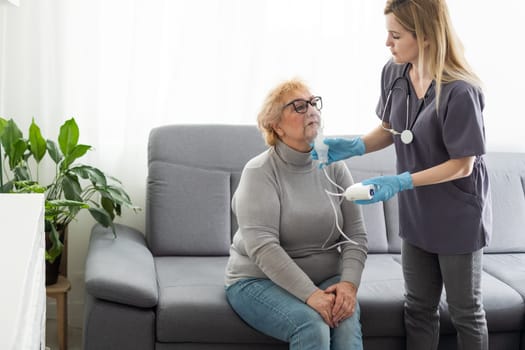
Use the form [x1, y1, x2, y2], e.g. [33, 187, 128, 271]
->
[355, 171, 414, 204]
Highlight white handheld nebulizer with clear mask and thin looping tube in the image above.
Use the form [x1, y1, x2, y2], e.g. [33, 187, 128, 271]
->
[313, 126, 374, 250]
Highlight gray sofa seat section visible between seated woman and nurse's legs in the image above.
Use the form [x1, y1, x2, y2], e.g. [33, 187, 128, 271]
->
[357, 254, 405, 337]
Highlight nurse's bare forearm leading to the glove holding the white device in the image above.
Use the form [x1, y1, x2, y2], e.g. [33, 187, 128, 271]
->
[411, 156, 476, 187]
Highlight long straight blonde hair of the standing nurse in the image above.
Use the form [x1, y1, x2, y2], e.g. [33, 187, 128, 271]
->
[384, 0, 482, 104]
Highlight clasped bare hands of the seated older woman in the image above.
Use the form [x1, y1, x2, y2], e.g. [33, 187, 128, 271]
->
[306, 282, 357, 328]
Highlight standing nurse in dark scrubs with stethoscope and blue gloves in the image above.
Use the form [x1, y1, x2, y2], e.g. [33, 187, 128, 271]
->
[313, 0, 491, 350]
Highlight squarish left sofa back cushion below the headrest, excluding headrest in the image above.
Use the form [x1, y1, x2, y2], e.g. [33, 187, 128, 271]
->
[147, 161, 230, 255]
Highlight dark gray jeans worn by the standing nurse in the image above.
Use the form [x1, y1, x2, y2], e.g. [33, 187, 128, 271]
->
[401, 241, 488, 350]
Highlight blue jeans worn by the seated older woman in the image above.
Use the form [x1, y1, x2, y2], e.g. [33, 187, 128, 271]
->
[226, 276, 363, 350]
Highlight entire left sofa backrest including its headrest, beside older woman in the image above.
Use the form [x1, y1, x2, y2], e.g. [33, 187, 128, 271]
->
[146, 125, 266, 256]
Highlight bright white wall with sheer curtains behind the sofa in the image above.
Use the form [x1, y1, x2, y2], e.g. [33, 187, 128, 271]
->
[0, 0, 525, 325]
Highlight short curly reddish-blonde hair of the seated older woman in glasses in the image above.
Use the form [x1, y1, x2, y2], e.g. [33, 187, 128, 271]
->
[257, 78, 310, 146]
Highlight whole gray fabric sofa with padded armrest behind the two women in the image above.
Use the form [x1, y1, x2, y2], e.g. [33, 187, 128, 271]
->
[83, 125, 525, 350]
